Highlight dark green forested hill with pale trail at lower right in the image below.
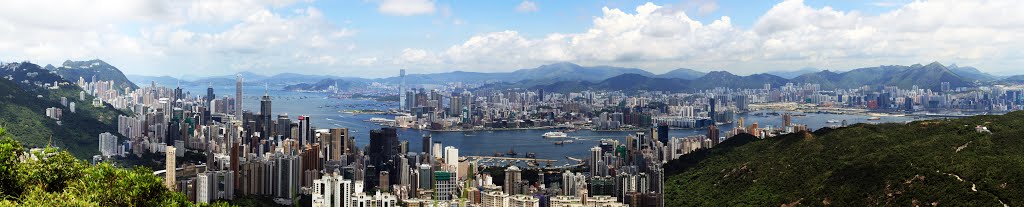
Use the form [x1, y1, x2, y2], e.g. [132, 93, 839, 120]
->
[665, 112, 1024, 206]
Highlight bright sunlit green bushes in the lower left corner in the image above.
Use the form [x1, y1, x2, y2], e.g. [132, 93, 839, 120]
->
[0, 128, 225, 206]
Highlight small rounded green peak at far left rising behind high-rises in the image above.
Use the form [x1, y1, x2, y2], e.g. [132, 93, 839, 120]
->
[45, 59, 138, 89]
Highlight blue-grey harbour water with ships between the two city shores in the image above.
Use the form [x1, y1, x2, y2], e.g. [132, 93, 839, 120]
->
[182, 86, 929, 165]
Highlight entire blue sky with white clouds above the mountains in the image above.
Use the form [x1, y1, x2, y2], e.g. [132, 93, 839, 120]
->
[0, 0, 1024, 78]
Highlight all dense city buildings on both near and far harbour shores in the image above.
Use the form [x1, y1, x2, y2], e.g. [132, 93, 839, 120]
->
[61, 66, 1024, 207]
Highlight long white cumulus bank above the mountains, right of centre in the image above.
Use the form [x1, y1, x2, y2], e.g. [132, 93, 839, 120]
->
[411, 0, 1024, 73]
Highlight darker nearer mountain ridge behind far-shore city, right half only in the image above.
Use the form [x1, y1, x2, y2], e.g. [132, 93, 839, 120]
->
[512, 63, 977, 92]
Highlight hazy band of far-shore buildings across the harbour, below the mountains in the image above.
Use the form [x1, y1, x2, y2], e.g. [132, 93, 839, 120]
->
[385, 79, 1024, 130]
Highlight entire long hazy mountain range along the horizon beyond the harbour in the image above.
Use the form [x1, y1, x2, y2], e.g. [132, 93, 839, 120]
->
[129, 59, 1001, 91]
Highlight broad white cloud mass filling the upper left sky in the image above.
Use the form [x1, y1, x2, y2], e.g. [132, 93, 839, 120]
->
[0, 0, 357, 75]
